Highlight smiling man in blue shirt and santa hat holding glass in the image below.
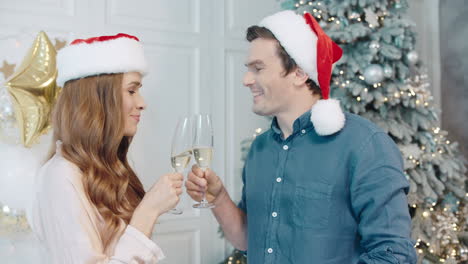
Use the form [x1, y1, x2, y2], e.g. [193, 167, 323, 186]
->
[186, 11, 416, 264]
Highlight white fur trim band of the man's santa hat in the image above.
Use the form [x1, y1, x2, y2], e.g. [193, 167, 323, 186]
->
[259, 10, 318, 83]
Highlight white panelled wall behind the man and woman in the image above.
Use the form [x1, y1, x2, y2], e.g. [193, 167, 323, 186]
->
[0, 0, 279, 264]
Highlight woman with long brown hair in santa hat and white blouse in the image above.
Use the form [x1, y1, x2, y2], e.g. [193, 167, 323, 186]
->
[33, 34, 182, 263]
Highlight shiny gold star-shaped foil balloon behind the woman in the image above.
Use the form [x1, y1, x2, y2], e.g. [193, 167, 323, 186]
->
[6, 31, 60, 147]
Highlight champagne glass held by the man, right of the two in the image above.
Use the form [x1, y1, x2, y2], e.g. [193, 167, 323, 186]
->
[192, 114, 214, 209]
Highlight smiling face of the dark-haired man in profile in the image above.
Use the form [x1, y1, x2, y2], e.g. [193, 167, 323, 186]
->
[243, 38, 294, 116]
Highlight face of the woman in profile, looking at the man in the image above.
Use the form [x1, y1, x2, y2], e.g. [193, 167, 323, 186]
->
[122, 72, 146, 137]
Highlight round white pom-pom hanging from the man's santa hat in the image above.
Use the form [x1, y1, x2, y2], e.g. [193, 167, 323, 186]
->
[310, 99, 345, 136]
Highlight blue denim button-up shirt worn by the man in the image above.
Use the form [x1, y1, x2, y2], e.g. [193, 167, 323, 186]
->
[239, 112, 416, 264]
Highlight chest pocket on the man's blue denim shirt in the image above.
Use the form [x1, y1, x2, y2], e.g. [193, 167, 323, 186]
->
[293, 182, 333, 229]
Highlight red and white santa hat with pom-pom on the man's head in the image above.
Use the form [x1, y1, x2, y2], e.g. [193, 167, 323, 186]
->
[259, 10, 345, 136]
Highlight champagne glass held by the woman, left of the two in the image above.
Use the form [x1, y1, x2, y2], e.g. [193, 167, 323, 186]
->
[170, 117, 192, 214]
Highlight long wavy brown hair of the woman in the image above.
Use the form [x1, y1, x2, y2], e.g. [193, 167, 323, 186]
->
[49, 74, 145, 248]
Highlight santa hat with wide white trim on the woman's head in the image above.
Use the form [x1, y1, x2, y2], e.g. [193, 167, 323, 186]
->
[57, 33, 148, 87]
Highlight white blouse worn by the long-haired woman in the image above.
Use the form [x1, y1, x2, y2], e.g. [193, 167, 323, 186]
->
[32, 141, 164, 264]
